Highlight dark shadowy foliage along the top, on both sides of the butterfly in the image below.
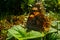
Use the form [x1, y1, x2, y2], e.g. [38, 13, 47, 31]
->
[0, 0, 60, 19]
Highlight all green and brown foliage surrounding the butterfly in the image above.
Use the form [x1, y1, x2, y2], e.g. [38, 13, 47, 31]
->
[0, 0, 60, 40]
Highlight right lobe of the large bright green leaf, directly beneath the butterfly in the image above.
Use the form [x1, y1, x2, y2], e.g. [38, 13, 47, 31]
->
[26, 30, 45, 39]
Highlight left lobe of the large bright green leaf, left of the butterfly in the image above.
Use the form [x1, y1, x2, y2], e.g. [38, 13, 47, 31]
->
[8, 25, 26, 39]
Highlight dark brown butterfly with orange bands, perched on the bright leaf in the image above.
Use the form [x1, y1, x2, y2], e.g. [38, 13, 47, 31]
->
[26, 3, 50, 31]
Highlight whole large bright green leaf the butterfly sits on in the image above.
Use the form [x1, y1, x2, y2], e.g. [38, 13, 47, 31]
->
[8, 25, 45, 40]
